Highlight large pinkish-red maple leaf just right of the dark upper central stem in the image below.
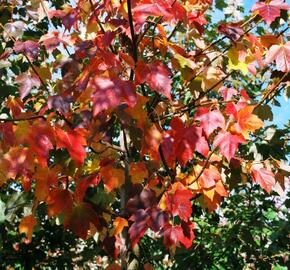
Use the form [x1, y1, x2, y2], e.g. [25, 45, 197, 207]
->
[135, 61, 172, 100]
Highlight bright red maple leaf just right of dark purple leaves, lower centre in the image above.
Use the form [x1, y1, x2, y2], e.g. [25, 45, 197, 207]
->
[166, 189, 193, 221]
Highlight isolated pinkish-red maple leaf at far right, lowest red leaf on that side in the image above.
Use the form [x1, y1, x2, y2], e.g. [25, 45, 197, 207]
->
[251, 166, 276, 193]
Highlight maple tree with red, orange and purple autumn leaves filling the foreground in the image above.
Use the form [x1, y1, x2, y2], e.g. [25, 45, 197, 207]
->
[0, 0, 290, 269]
